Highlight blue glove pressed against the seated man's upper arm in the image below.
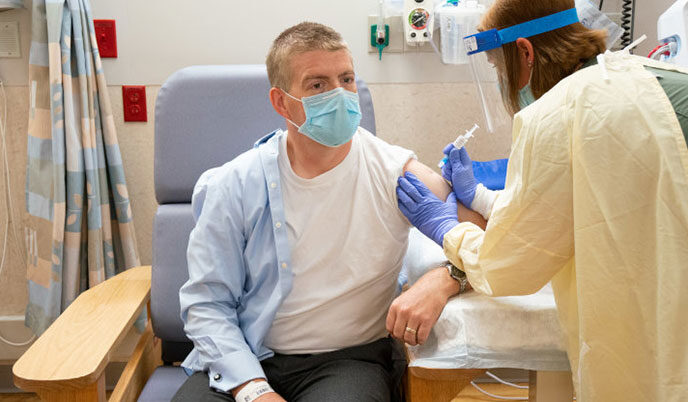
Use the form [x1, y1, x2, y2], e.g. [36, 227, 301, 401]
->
[397, 172, 459, 246]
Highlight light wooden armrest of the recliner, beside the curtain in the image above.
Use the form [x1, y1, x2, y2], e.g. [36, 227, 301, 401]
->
[12, 266, 151, 395]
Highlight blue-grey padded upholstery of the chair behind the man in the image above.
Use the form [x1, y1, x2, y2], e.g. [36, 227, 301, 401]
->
[138, 65, 375, 402]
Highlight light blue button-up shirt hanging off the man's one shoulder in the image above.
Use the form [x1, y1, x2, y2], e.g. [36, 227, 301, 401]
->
[180, 131, 293, 391]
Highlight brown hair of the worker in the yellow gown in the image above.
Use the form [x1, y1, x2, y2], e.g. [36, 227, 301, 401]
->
[478, 0, 607, 113]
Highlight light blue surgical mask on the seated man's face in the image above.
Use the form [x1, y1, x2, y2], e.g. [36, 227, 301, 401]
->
[284, 87, 361, 147]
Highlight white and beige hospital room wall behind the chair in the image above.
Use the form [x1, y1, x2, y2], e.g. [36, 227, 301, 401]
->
[0, 0, 671, 330]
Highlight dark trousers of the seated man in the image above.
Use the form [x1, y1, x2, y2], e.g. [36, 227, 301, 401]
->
[172, 338, 406, 402]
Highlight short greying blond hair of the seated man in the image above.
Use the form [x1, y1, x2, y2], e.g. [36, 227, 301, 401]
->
[265, 22, 349, 91]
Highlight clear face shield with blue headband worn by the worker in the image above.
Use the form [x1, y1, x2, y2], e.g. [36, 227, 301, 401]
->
[464, 8, 579, 124]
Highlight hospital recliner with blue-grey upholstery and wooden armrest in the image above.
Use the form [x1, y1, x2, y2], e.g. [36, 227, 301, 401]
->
[13, 65, 375, 402]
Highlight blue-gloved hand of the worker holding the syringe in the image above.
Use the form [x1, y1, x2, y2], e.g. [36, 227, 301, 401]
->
[442, 144, 478, 209]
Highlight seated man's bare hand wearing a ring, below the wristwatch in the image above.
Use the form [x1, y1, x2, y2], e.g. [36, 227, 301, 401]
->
[386, 267, 460, 346]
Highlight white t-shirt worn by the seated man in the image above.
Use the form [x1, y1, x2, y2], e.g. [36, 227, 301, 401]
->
[265, 127, 415, 354]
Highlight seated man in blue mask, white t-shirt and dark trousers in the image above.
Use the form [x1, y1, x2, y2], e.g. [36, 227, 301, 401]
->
[175, 23, 484, 402]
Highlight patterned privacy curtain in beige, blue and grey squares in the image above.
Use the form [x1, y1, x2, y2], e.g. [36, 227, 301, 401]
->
[26, 0, 139, 334]
